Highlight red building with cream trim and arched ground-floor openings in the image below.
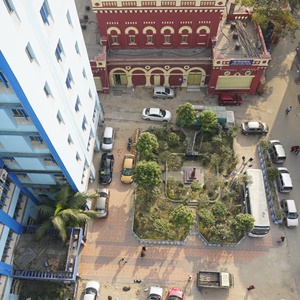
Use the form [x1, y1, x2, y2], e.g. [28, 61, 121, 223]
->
[91, 0, 270, 94]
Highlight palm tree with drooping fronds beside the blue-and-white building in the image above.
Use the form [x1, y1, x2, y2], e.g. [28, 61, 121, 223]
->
[36, 185, 97, 242]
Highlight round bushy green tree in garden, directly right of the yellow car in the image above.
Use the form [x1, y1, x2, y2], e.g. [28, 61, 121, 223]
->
[133, 160, 161, 189]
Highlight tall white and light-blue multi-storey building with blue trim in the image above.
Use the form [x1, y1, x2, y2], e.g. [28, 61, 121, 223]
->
[0, 0, 102, 299]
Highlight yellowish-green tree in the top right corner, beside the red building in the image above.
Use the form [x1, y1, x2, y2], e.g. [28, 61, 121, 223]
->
[237, 0, 299, 40]
